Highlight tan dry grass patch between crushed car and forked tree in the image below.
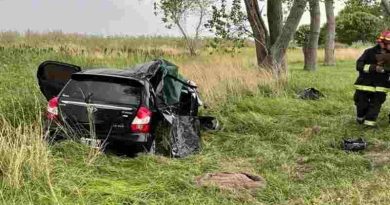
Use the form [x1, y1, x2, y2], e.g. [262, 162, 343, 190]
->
[180, 55, 275, 105]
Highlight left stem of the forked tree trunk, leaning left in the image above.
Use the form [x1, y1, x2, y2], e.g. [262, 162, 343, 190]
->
[245, 0, 268, 66]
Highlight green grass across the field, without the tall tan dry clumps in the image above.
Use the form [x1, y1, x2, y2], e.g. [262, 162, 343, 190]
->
[0, 35, 390, 204]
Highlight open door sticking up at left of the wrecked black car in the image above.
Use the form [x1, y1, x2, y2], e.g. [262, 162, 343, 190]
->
[37, 61, 81, 100]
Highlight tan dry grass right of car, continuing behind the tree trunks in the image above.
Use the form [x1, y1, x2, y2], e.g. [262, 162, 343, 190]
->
[179, 48, 364, 105]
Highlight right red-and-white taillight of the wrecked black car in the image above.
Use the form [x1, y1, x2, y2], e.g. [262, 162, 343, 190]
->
[131, 107, 152, 133]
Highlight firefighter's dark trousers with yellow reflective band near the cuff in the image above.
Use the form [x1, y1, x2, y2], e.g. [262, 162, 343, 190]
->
[354, 90, 386, 125]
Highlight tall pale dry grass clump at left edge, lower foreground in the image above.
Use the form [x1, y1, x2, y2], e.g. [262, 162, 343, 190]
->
[0, 119, 50, 188]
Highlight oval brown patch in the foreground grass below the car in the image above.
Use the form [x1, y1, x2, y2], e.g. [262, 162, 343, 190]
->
[196, 172, 266, 190]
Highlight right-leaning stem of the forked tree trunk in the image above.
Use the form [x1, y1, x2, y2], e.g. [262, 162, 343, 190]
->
[270, 0, 307, 76]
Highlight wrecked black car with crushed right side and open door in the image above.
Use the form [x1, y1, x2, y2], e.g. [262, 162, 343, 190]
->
[37, 60, 215, 157]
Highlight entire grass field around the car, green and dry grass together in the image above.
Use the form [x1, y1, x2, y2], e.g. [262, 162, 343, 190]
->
[0, 33, 390, 204]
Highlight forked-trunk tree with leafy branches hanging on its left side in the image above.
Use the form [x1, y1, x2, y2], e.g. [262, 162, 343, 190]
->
[207, 0, 307, 76]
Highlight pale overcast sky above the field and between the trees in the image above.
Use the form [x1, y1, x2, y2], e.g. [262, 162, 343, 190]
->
[0, 0, 342, 36]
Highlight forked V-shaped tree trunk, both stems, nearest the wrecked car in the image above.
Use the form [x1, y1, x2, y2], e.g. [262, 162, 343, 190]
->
[244, 0, 307, 74]
